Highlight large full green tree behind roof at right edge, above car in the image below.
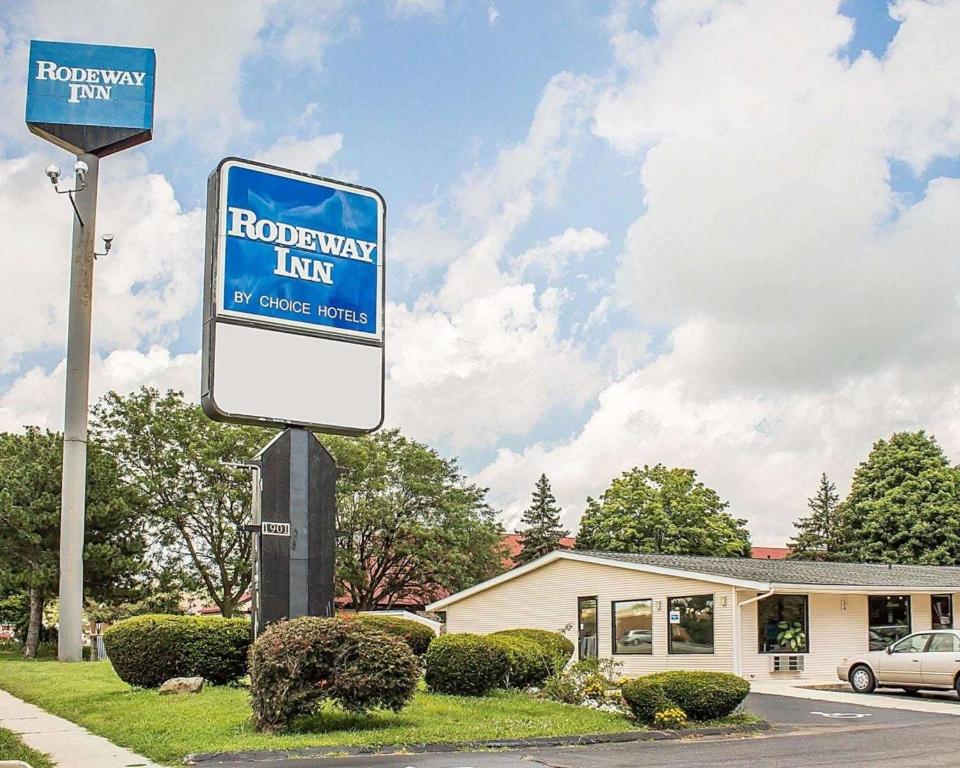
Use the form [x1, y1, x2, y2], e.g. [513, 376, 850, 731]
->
[843, 430, 960, 565]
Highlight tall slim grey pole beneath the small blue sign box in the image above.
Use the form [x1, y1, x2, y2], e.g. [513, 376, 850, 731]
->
[57, 154, 100, 661]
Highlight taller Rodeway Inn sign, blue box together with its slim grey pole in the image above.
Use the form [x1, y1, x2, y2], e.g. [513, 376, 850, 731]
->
[26, 40, 156, 661]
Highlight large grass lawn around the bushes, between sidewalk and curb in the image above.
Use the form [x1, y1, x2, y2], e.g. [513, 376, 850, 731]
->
[0, 658, 636, 764]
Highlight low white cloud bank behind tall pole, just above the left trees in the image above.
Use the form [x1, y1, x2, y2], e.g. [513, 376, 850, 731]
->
[0, 347, 200, 431]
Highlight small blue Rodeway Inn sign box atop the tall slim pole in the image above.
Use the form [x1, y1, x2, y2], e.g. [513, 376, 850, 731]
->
[26, 40, 156, 157]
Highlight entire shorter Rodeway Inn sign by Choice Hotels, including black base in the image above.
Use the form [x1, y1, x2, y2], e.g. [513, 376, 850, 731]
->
[201, 158, 386, 632]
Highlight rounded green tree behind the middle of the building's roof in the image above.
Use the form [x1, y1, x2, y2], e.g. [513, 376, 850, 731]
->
[577, 464, 750, 557]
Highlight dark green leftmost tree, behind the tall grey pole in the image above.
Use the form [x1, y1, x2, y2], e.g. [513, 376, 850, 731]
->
[0, 427, 146, 658]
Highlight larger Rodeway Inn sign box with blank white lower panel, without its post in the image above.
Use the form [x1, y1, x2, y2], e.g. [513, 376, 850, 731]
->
[201, 158, 385, 434]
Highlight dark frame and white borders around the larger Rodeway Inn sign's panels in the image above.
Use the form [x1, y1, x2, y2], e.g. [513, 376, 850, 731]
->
[200, 155, 387, 436]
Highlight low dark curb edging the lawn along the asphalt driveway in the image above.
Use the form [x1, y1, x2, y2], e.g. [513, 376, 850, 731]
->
[183, 720, 770, 766]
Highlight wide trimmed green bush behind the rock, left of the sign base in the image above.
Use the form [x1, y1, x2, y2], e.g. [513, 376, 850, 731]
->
[103, 614, 250, 688]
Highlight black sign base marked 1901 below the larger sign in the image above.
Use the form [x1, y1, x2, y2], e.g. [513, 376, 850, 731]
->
[254, 428, 337, 635]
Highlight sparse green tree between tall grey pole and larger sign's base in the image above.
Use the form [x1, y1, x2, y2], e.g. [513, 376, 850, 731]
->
[92, 387, 270, 616]
